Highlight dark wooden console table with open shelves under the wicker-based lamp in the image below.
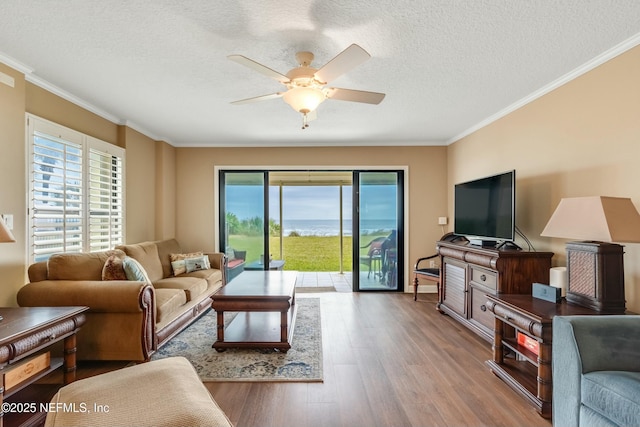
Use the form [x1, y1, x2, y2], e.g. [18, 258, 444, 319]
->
[486, 295, 601, 418]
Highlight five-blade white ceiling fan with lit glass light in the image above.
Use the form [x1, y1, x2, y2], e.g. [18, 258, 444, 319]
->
[227, 44, 385, 129]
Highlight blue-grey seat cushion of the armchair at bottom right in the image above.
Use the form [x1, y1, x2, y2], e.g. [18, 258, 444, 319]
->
[581, 371, 640, 426]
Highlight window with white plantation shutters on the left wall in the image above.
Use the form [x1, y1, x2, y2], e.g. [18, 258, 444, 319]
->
[27, 114, 125, 262]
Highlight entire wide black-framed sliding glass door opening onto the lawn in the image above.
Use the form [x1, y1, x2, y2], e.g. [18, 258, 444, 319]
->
[219, 170, 404, 291]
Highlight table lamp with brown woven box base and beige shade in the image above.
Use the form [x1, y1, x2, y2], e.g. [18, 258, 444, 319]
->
[540, 196, 640, 314]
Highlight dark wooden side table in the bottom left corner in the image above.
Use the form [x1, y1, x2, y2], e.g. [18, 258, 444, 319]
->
[0, 307, 89, 427]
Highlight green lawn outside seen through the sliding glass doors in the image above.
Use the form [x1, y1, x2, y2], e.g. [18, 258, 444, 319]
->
[229, 235, 380, 271]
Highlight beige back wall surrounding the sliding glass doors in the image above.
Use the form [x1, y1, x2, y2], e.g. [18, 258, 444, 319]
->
[176, 147, 447, 290]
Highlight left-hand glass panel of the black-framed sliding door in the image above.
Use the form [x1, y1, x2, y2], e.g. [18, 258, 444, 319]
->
[220, 171, 268, 281]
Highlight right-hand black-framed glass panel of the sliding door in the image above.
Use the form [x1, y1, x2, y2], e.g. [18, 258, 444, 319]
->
[353, 171, 404, 291]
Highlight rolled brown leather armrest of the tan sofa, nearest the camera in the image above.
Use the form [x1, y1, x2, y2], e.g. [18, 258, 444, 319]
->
[17, 280, 153, 313]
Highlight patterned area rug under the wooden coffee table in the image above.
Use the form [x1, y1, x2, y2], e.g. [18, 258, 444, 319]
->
[151, 298, 322, 382]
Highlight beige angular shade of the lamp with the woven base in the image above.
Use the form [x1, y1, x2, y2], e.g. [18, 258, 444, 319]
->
[540, 196, 640, 243]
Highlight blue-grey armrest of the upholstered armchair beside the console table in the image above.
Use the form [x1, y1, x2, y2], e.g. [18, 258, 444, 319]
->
[552, 315, 640, 426]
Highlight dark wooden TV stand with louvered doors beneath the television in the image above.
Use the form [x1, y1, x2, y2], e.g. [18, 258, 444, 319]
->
[436, 240, 553, 342]
